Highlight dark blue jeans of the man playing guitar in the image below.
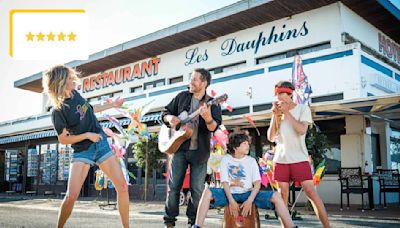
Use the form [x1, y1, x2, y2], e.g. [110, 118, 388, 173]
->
[164, 150, 207, 226]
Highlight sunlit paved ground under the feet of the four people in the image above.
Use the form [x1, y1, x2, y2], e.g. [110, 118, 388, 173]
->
[0, 199, 400, 228]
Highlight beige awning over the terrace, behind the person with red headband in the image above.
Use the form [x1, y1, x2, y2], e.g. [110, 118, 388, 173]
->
[223, 94, 400, 128]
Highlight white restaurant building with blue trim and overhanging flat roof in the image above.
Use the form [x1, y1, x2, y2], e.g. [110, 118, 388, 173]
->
[0, 0, 400, 203]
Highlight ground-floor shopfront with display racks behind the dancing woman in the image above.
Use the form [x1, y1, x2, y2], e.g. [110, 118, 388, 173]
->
[1, 119, 165, 198]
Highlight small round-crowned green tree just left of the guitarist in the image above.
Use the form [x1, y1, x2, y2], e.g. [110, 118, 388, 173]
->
[132, 133, 165, 201]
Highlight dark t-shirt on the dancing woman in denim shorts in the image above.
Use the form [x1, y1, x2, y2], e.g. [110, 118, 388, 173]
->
[51, 90, 101, 153]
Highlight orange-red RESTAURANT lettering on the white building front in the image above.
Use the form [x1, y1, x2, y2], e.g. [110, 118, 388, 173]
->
[82, 58, 160, 93]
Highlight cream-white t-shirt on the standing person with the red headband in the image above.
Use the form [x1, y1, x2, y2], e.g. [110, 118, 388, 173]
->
[271, 104, 312, 164]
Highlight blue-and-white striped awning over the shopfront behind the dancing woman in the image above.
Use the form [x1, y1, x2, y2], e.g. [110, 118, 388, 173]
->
[0, 112, 161, 145]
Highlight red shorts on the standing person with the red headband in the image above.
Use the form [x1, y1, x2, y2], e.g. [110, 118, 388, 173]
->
[273, 161, 313, 183]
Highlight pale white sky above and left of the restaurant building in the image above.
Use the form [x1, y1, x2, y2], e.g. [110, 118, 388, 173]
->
[0, 0, 237, 123]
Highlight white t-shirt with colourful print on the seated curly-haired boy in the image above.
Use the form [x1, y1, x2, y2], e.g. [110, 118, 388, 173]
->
[220, 154, 261, 194]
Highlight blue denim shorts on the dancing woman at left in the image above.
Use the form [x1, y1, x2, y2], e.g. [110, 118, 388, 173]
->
[71, 132, 114, 165]
